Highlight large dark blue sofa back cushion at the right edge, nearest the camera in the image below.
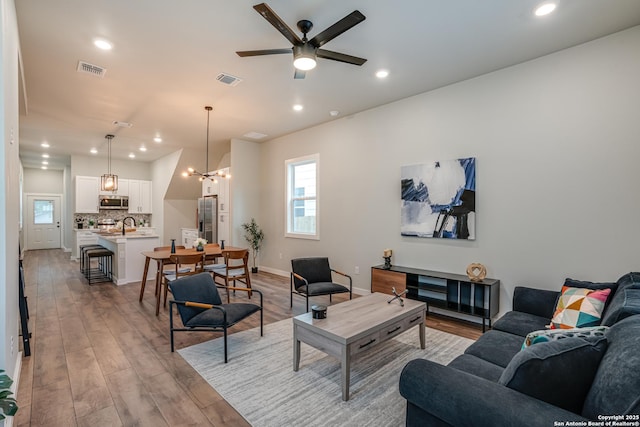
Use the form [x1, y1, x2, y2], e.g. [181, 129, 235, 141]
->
[584, 315, 640, 419]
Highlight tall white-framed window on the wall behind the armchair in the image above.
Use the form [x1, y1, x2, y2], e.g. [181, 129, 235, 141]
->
[285, 154, 319, 239]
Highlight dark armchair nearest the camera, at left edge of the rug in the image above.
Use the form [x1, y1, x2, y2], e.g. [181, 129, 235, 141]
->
[169, 273, 264, 363]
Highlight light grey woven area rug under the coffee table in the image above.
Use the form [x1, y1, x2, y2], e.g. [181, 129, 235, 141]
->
[178, 319, 473, 427]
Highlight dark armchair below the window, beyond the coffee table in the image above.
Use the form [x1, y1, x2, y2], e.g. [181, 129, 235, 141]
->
[290, 257, 353, 311]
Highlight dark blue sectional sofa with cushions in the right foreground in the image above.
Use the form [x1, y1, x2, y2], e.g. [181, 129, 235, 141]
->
[400, 273, 640, 427]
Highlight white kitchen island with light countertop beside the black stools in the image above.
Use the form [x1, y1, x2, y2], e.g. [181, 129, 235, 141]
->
[95, 232, 160, 285]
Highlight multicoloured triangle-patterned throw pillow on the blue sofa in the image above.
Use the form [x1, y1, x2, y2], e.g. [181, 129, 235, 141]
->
[550, 286, 611, 329]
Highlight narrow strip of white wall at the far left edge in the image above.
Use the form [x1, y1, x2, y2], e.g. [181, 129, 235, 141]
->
[0, 0, 20, 390]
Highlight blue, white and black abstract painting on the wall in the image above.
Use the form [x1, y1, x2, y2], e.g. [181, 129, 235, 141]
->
[400, 157, 476, 240]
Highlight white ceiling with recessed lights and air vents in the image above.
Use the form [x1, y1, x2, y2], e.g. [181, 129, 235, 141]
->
[15, 0, 640, 168]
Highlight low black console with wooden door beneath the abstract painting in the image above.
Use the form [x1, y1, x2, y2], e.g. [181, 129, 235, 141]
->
[371, 265, 500, 332]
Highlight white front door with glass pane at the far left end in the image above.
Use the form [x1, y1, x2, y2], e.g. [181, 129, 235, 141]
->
[25, 195, 61, 249]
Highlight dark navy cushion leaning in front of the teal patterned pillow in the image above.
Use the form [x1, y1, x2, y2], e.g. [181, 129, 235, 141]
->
[498, 338, 607, 414]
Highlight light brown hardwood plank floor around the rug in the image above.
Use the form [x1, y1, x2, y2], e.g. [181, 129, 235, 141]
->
[14, 250, 481, 427]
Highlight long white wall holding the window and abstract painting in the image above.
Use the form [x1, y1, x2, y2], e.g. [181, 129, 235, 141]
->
[255, 27, 640, 312]
